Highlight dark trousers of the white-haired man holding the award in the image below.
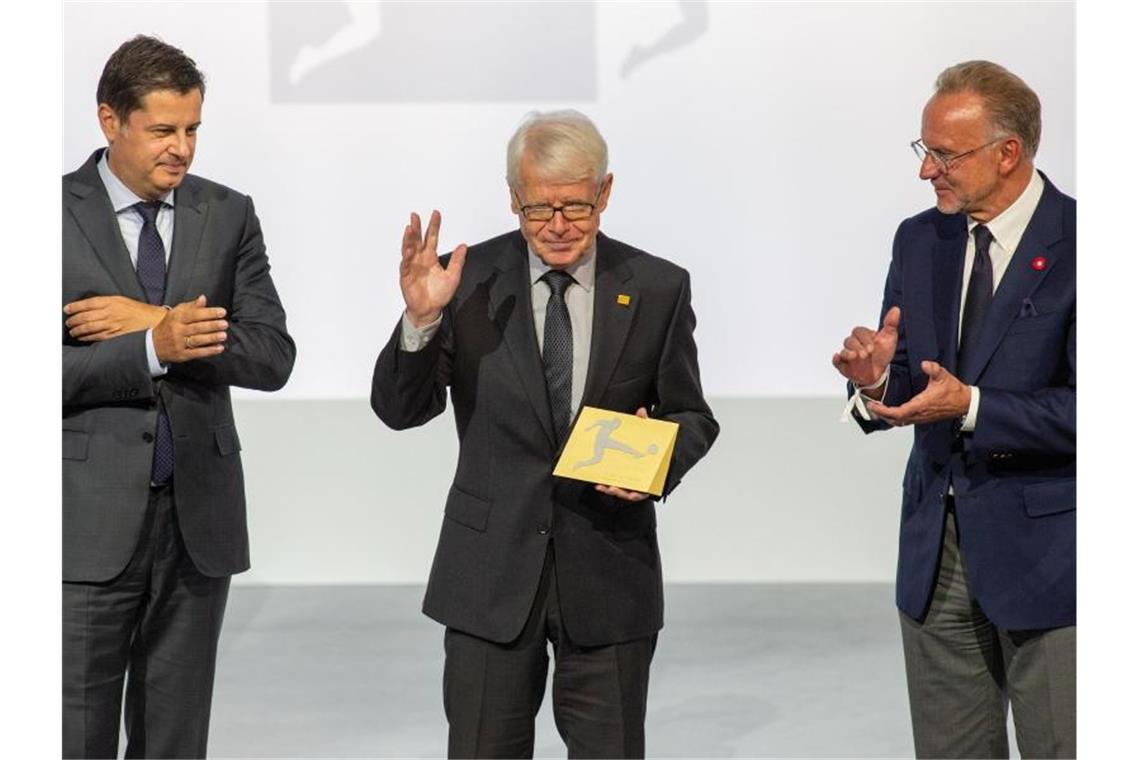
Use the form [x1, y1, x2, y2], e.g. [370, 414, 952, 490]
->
[443, 548, 657, 758]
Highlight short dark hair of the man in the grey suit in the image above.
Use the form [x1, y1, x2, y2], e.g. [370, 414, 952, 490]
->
[95, 34, 206, 121]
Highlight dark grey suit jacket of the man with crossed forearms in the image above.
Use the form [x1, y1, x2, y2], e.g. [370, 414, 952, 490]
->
[63, 149, 296, 581]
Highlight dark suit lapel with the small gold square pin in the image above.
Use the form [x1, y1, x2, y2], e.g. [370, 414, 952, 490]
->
[581, 232, 641, 406]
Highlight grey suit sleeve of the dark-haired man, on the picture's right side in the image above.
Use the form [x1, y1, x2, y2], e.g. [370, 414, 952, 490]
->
[170, 198, 296, 391]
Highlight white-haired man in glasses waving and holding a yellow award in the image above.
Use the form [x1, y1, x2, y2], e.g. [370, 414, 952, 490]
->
[372, 111, 719, 758]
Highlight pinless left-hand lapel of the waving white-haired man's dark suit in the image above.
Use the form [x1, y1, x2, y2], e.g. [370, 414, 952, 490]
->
[490, 234, 556, 446]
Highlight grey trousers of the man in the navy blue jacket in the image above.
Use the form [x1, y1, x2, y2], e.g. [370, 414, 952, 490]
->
[899, 501, 1076, 758]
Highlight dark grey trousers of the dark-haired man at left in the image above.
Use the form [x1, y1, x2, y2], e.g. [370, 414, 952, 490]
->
[63, 487, 229, 758]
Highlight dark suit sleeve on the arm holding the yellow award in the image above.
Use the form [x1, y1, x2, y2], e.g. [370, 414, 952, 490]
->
[652, 272, 720, 496]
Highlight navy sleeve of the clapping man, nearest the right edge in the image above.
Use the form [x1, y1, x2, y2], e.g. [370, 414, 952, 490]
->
[972, 307, 1076, 457]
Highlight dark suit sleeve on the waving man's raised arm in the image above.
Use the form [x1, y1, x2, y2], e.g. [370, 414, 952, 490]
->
[372, 308, 453, 430]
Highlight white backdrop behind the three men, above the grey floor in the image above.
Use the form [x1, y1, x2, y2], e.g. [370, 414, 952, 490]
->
[62, 1, 1076, 582]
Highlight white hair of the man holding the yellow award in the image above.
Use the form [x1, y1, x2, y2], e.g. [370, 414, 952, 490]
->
[506, 109, 609, 189]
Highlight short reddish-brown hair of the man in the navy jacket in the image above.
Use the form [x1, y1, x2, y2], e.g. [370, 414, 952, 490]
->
[934, 60, 1041, 158]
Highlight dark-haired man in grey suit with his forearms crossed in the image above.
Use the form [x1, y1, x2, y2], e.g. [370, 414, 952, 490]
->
[63, 36, 295, 758]
